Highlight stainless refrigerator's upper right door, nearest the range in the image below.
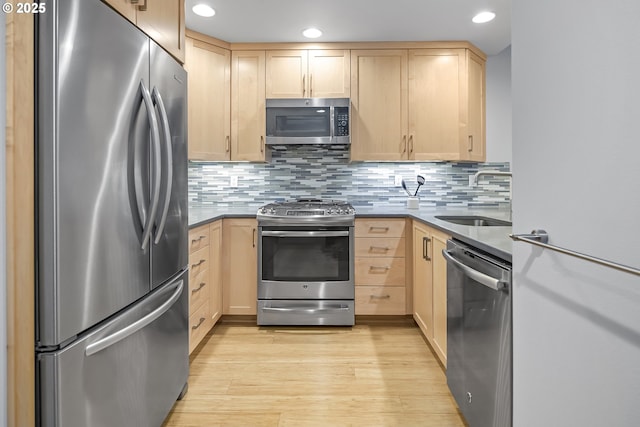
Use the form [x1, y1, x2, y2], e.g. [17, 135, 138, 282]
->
[149, 41, 189, 287]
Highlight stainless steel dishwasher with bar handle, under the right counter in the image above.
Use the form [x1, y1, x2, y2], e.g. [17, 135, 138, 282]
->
[442, 240, 512, 427]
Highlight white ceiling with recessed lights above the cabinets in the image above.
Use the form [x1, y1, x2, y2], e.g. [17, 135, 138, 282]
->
[185, 0, 511, 55]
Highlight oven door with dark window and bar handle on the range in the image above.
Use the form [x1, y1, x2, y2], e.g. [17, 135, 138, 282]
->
[258, 226, 354, 300]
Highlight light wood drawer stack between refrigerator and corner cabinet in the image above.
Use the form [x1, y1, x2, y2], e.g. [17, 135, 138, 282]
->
[189, 221, 222, 353]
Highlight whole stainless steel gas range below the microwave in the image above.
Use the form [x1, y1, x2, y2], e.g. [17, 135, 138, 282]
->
[257, 199, 355, 325]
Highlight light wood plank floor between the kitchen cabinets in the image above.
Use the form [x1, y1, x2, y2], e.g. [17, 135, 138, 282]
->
[164, 319, 465, 427]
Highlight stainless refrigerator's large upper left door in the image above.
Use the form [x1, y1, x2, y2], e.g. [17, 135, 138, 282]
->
[37, 0, 156, 346]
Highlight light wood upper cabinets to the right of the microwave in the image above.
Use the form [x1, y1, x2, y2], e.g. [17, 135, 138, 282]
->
[351, 48, 485, 161]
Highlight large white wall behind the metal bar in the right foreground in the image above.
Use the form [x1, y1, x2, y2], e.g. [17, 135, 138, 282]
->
[511, 0, 640, 427]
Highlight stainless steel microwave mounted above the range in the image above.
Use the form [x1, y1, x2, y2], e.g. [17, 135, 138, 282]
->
[266, 98, 351, 145]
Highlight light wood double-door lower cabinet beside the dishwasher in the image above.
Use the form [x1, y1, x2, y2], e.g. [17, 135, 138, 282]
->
[412, 221, 450, 367]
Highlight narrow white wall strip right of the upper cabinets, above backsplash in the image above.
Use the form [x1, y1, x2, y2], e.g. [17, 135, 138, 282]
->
[486, 46, 511, 162]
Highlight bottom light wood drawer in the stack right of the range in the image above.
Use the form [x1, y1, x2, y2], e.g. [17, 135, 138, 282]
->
[355, 286, 405, 315]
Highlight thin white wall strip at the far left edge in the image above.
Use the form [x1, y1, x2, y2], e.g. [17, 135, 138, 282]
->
[0, 14, 7, 427]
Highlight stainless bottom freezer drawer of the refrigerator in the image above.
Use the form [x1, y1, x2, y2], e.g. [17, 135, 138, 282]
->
[37, 273, 189, 427]
